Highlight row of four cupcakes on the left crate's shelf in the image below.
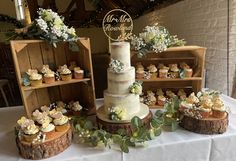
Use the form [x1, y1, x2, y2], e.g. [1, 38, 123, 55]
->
[23, 63, 84, 86]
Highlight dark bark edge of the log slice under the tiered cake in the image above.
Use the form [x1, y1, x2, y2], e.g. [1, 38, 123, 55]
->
[97, 112, 152, 134]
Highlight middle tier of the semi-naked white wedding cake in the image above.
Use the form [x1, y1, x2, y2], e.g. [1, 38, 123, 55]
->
[107, 67, 135, 94]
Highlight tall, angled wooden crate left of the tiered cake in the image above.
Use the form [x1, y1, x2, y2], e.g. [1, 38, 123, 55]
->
[11, 38, 96, 117]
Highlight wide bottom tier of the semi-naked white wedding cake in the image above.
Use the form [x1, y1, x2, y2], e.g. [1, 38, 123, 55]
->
[104, 90, 140, 115]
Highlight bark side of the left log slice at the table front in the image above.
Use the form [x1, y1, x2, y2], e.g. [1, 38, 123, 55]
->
[16, 124, 72, 160]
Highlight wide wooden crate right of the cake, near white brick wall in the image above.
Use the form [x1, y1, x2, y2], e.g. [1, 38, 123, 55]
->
[131, 46, 206, 108]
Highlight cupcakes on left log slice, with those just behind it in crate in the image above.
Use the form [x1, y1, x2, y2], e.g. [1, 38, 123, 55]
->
[16, 101, 82, 143]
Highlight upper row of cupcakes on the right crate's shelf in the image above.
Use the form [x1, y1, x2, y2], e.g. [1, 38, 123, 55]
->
[136, 62, 193, 79]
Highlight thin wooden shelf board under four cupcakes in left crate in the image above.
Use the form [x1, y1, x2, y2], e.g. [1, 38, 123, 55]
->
[21, 78, 90, 91]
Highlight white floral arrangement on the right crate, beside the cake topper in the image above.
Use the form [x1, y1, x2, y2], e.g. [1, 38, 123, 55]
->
[131, 23, 185, 56]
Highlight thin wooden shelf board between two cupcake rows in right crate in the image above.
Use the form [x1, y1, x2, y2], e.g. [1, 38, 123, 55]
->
[136, 77, 202, 82]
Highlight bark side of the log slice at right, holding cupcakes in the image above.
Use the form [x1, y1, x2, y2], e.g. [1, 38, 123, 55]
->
[180, 114, 229, 134]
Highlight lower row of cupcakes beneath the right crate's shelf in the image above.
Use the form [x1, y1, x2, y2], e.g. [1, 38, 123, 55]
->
[140, 89, 190, 106]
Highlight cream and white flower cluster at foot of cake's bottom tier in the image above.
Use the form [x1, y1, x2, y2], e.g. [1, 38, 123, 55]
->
[109, 106, 126, 121]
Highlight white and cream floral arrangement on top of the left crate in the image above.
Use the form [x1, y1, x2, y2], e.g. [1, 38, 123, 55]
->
[8, 8, 78, 47]
